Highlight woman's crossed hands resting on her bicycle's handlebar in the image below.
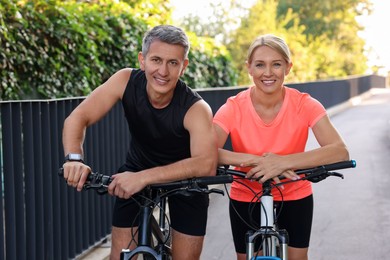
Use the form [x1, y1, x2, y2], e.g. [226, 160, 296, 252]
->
[240, 153, 299, 183]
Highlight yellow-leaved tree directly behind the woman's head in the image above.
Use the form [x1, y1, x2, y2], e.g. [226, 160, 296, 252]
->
[228, 0, 314, 85]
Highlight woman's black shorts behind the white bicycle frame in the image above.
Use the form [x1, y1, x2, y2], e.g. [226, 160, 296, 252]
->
[229, 195, 313, 254]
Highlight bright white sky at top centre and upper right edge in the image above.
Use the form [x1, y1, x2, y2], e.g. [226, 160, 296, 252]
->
[171, 0, 390, 75]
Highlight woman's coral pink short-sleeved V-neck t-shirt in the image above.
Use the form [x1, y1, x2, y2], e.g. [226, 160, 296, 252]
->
[214, 87, 326, 202]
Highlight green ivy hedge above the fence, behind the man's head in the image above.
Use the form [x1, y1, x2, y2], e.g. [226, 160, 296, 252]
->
[0, 0, 237, 100]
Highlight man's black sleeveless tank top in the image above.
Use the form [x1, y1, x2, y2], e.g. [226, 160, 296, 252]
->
[122, 69, 202, 171]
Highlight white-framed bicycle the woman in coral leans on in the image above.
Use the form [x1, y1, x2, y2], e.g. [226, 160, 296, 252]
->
[218, 160, 356, 260]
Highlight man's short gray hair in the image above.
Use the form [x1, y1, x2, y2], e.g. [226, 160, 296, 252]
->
[142, 25, 190, 59]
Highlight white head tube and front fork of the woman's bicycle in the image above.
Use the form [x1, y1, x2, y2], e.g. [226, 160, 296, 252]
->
[246, 182, 288, 260]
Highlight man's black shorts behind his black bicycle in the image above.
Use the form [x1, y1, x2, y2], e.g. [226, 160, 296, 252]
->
[112, 190, 209, 236]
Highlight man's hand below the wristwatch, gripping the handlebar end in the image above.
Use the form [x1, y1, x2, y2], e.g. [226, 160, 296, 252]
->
[62, 161, 91, 191]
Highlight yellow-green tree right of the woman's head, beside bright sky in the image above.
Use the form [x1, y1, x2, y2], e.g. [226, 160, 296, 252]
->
[278, 0, 372, 78]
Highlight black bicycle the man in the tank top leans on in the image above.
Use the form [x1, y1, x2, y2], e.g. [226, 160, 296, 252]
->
[59, 168, 233, 260]
